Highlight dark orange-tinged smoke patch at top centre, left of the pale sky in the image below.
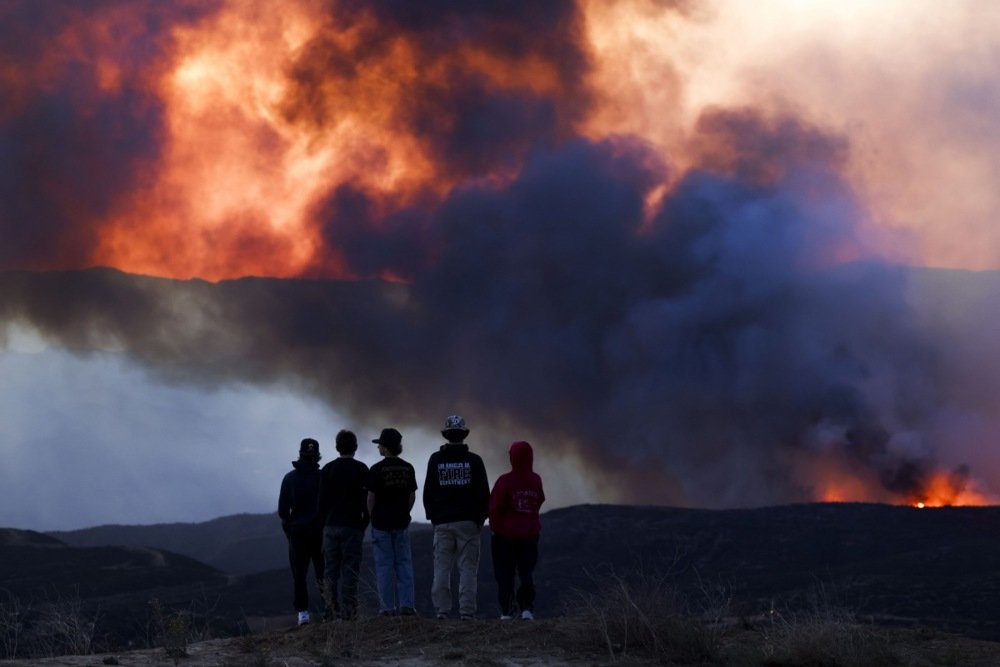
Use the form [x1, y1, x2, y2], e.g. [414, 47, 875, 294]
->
[285, 0, 592, 177]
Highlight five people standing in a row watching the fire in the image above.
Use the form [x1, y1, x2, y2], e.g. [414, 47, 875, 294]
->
[278, 415, 545, 625]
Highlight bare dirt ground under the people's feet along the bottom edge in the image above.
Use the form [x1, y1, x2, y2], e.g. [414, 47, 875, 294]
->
[0, 618, 1000, 667]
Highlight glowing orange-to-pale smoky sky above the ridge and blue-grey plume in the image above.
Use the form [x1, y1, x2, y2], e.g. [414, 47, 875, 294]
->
[0, 0, 1000, 280]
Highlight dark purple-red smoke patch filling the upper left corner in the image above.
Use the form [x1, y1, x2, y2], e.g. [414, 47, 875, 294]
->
[0, 0, 221, 268]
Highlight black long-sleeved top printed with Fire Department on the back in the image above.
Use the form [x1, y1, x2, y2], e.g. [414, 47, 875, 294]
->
[424, 443, 490, 526]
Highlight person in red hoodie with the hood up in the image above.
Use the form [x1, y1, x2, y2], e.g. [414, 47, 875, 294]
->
[489, 440, 545, 621]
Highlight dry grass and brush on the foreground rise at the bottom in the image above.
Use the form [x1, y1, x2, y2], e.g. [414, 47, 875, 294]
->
[0, 572, 1000, 667]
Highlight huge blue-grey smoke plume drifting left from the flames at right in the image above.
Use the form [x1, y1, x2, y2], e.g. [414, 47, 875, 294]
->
[0, 108, 965, 506]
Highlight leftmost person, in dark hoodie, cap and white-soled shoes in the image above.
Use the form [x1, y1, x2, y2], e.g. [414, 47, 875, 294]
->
[278, 438, 324, 625]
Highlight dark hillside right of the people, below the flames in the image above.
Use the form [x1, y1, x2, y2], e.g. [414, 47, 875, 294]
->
[540, 503, 1000, 637]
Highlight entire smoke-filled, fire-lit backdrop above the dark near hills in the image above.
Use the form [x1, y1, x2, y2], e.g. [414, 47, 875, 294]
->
[0, 0, 1000, 530]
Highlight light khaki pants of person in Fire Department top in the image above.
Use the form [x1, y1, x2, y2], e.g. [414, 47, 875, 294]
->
[431, 521, 480, 616]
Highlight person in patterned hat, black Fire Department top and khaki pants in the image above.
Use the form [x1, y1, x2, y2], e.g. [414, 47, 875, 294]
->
[423, 415, 490, 619]
